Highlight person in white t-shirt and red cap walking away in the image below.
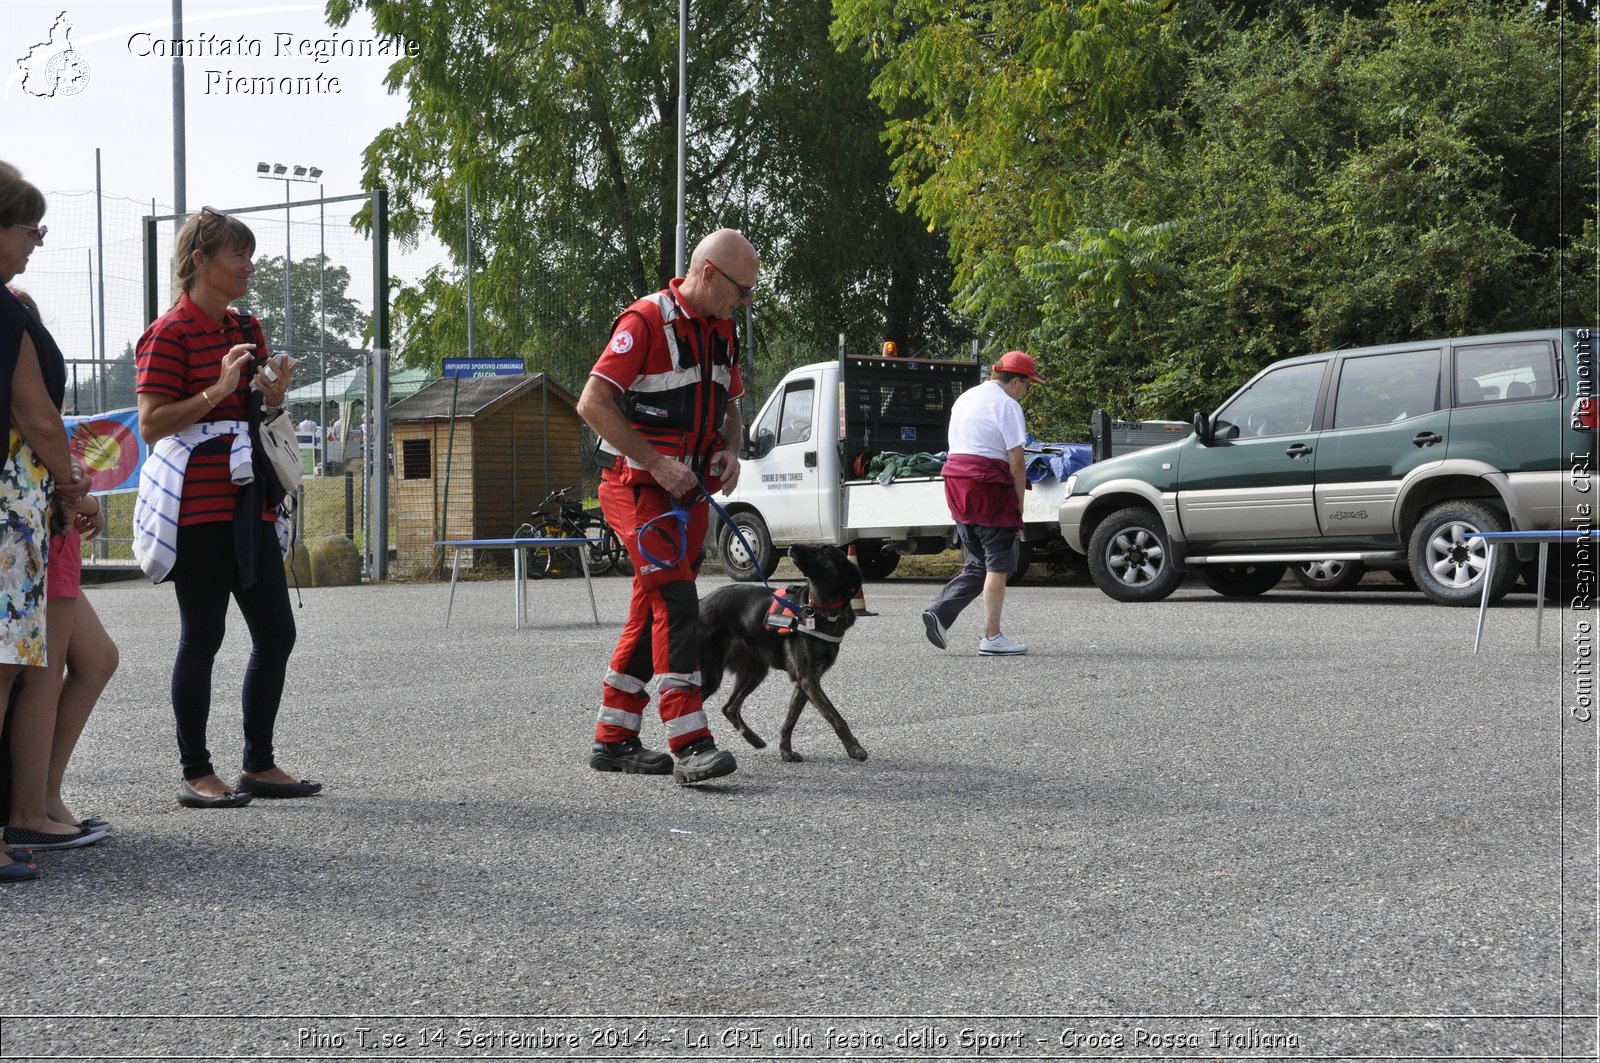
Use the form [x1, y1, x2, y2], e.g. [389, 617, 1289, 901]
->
[922, 351, 1045, 656]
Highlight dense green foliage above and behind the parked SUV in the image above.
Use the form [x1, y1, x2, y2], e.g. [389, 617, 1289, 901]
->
[834, 0, 1597, 434]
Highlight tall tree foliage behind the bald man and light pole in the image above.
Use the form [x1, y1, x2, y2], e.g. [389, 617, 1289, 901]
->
[318, 0, 954, 400]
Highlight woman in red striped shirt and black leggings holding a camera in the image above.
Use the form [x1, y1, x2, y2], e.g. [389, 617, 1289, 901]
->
[134, 207, 322, 808]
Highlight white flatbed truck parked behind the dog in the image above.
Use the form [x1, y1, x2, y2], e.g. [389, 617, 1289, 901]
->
[714, 354, 1094, 581]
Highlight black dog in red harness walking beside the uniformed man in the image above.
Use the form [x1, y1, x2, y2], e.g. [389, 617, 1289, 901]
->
[701, 546, 867, 760]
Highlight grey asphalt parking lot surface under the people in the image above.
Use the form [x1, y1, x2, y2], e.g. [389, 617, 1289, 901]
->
[0, 578, 1597, 1060]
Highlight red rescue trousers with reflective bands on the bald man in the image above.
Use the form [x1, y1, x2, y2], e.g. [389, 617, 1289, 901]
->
[595, 471, 710, 752]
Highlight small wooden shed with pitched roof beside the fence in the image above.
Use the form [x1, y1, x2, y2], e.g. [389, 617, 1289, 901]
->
[389, 373, 586, 567]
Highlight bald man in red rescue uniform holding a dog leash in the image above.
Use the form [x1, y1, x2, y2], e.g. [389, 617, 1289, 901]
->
[578, 229, 762, 784]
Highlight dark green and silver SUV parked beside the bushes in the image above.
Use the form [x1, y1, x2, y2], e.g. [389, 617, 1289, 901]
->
[1061, 328, 1597, 605]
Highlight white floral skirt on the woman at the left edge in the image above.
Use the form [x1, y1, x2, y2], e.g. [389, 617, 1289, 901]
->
[0, 424, 50, 666]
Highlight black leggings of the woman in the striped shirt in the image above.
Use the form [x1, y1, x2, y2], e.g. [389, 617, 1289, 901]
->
[171, 520, 294, 780]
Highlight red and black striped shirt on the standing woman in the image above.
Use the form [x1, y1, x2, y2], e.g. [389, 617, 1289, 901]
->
[134, 295, 275, 525]
